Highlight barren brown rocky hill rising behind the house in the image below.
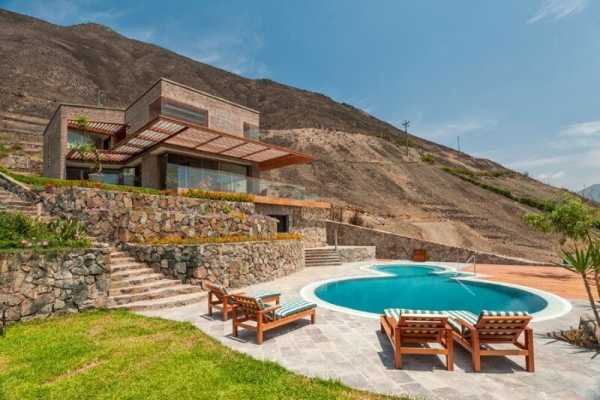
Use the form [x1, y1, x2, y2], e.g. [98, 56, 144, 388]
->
[0, 10, 576, 261]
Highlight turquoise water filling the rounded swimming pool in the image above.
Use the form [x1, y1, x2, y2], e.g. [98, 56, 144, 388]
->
[315, 265, 547, 314]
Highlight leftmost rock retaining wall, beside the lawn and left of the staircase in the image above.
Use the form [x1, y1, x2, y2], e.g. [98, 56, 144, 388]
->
[0, 248, 110, 322]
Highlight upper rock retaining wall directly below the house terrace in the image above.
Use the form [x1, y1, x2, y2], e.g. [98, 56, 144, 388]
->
[38, 187, 277, 242]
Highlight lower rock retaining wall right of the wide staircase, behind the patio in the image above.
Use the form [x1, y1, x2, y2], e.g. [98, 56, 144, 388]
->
[122, 240, 304, 288]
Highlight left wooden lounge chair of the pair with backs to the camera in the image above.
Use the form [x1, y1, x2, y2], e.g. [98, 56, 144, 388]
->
[380, 308, 454, 371]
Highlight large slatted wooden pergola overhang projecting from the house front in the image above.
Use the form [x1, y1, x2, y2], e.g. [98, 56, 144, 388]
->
[67, 115, 314, 171]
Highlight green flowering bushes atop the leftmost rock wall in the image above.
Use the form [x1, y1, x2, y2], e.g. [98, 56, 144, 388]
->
[0, 212, 90, 249]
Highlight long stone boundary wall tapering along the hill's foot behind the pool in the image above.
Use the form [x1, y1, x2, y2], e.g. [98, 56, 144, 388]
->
[326, 221, 543, 265]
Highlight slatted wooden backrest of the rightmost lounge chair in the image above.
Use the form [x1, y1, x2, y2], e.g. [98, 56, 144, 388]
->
[475, 310, 531, 340]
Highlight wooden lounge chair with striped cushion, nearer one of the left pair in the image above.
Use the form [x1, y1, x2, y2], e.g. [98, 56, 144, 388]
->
[230, 295, 317, 344]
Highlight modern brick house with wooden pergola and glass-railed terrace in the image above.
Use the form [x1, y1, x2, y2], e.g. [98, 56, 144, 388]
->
[43, 78, 313, 199]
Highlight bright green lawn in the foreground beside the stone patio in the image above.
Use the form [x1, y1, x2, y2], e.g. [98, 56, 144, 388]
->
[0, 311, 406, 400]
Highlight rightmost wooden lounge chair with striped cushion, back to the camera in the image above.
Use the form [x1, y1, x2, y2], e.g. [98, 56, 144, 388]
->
[448, 310, 535, 372]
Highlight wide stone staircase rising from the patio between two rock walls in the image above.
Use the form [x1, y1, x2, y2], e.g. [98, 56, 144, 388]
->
[108, 250, 207, 311]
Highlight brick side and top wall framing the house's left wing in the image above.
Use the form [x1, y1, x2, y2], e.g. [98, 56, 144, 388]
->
[43, 104, 125, 179]
